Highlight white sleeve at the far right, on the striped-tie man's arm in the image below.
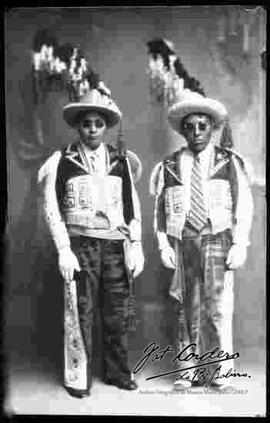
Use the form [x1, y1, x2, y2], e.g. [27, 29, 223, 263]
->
[232, 158, 253, 246]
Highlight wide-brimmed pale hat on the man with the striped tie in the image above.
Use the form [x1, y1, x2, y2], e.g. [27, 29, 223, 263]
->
[168, 89, 228, 133]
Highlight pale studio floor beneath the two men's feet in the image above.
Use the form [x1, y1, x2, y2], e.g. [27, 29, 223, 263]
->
[5, 328, 266, 417]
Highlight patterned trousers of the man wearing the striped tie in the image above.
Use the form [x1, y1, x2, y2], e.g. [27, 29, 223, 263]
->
[177, 230, 234, 380]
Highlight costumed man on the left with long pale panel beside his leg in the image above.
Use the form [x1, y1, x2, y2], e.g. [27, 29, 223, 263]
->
[39, 89, 144, 398]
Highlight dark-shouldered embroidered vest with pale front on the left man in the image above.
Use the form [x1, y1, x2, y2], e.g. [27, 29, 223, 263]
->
[56, 143, 133, 230]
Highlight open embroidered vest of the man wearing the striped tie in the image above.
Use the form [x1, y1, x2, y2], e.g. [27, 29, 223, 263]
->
[163, 146, 239, 239]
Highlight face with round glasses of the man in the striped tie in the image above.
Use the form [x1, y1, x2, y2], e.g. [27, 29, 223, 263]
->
[182, 114, 213, 154]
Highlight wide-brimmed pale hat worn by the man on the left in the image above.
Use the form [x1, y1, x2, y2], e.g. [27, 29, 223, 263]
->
[63, 89, 122, 128]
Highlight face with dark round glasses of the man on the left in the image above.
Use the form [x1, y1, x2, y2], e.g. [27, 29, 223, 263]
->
[78, 112, 107, 150]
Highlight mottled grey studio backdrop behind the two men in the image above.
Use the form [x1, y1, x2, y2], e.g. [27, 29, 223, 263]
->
[5, 6, 266, 378]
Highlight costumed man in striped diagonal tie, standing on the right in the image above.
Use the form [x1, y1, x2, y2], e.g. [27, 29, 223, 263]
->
[150, 89, 253, 389]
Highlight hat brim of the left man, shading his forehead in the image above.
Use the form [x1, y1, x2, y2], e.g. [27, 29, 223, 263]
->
[63, 103, 122, 128]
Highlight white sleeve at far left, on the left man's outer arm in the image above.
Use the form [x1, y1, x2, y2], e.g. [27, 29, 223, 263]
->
[38, 151, 70, 252]
